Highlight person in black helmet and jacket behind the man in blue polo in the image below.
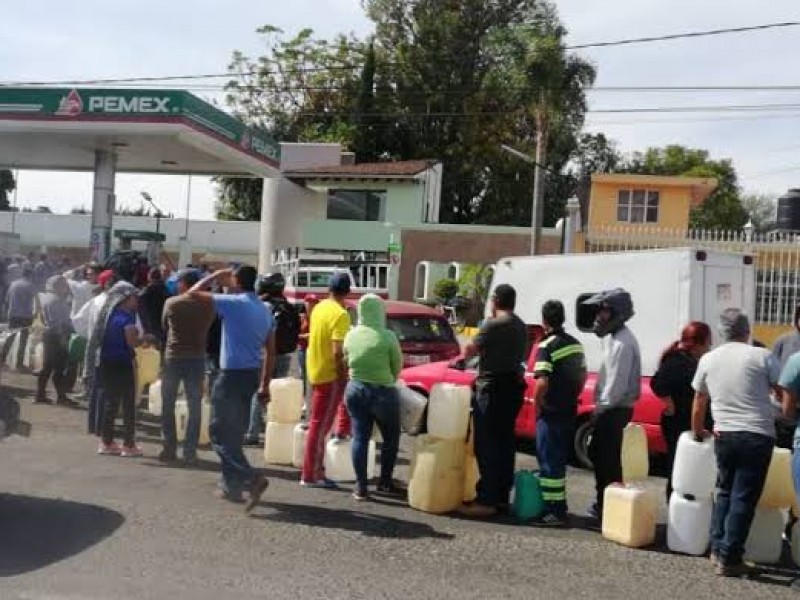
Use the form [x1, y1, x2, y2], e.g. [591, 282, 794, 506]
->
[244, 272, 300, 446]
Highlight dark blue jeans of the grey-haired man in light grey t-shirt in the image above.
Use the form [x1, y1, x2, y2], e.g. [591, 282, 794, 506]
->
[711, 431, 775, 565]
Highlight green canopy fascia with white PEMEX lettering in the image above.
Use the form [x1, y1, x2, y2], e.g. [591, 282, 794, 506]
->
[0, 87, 280, 164]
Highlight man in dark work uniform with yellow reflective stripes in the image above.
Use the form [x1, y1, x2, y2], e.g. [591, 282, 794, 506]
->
[533, 300, 586, 527]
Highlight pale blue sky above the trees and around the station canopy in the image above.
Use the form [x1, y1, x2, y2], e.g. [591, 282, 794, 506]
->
[0, 0, 800, 218]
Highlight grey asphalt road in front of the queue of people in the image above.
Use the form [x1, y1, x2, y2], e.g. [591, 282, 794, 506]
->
[0, 376, 795, 600]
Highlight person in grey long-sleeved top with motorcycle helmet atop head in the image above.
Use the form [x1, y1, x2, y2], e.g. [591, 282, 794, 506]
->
[584, 288, 642, 520]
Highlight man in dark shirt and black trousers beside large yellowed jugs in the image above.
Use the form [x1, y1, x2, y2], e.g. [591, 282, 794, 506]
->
[459, 284, 528, 518]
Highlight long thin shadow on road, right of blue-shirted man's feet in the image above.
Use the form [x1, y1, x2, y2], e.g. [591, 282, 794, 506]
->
[253, 502, 454, 540]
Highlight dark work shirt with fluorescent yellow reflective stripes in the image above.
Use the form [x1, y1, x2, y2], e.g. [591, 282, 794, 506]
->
[533, 330, 586, 417]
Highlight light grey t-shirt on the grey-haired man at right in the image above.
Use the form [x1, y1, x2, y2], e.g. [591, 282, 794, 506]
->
[692, 342, 780, 438]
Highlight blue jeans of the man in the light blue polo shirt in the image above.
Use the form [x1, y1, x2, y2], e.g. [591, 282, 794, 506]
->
[209, 369, 261, 498]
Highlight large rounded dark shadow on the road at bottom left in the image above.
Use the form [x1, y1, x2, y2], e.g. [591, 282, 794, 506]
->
[0, 494, 125, 577]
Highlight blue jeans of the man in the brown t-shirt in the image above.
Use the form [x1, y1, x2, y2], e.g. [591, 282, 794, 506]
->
[161, 358, 206, 459]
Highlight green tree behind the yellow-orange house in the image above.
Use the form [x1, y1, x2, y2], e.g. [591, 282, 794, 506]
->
[621, 145, 748, 229]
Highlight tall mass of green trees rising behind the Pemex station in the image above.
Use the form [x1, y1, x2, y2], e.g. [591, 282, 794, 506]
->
[220, 0, 594, 225]
